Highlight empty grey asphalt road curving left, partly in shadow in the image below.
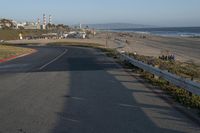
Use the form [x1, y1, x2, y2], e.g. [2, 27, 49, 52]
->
[0, 47, 200, 133]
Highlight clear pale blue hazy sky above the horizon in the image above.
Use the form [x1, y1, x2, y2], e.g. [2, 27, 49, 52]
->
[0, 0, 200, 26]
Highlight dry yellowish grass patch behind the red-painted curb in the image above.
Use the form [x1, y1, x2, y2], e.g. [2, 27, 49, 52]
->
[0, 45, 32, 60]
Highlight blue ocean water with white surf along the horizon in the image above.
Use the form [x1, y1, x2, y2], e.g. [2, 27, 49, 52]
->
[108, 27, 200, 37]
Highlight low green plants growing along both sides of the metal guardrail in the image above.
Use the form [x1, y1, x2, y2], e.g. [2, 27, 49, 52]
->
[102, 49, 200, 109]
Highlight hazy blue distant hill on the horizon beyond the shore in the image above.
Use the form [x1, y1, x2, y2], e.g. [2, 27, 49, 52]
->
[82, 23, 155, 30]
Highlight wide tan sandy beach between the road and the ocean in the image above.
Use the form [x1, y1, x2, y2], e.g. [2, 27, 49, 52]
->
[8, 32, 200, 64]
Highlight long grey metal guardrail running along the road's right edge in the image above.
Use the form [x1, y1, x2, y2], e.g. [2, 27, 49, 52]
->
[120, 54, 200, 96]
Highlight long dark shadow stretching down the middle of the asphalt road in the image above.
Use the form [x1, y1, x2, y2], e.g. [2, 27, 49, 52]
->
[46, 46, 191, 133]
